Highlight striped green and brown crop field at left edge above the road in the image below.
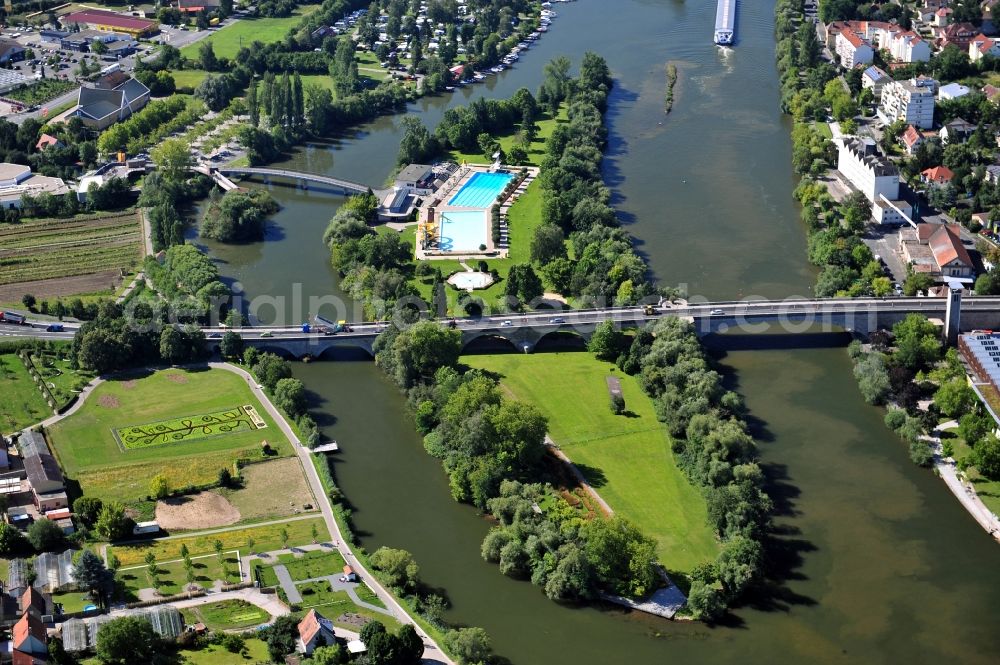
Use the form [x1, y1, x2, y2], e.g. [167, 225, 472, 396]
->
[0, 212, 143, 285]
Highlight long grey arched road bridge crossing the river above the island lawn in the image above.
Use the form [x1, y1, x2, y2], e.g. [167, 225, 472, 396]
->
[13, 292, 1000, 357]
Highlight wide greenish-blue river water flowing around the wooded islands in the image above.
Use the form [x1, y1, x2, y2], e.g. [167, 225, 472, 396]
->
[199, 0, 1000, 665]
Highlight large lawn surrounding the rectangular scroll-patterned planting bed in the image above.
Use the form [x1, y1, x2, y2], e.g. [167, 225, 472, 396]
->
[49, 369, 292, 501]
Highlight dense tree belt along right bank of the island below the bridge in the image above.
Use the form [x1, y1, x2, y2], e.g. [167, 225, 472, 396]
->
[595, 317, 772, 620]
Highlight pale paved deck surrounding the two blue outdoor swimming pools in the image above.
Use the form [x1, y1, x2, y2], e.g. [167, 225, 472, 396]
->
[415, 164, 539, 260]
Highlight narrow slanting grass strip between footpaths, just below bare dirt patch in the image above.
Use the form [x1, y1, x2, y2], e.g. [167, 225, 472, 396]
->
[109, 517, 330, 567]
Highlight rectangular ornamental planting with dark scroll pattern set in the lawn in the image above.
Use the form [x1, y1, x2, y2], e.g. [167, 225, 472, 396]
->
[115, 404, 267, 450]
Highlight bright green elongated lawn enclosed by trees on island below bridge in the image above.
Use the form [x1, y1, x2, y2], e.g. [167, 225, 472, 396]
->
[462, 352, 718, 571]
